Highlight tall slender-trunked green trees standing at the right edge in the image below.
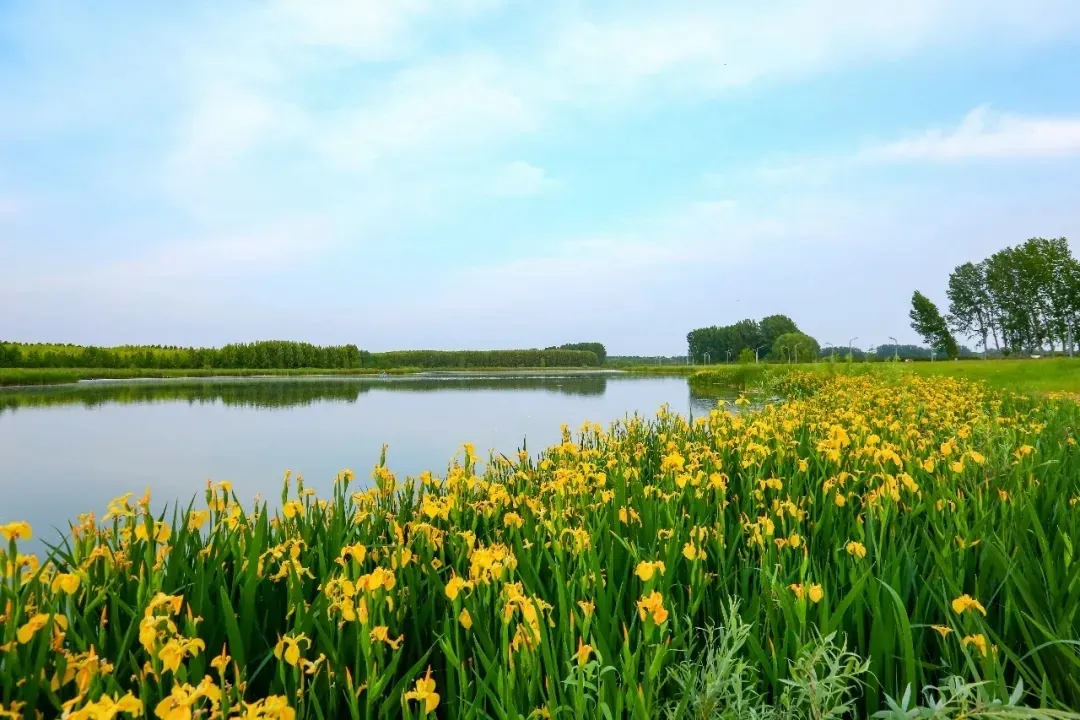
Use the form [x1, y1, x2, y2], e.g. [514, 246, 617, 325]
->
[910, 237, 1080, 357]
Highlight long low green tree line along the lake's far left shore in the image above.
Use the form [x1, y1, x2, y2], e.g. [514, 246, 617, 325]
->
[0, 340, 606, 370]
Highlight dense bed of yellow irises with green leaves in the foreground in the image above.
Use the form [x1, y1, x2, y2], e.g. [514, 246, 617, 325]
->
[0, 373, 1080, 720]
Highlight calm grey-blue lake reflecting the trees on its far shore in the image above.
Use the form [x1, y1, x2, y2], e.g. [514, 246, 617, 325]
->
[0, 372, 718, 549]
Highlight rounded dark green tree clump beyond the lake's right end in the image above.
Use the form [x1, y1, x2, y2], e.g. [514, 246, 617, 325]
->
[686, 315, 821, 364]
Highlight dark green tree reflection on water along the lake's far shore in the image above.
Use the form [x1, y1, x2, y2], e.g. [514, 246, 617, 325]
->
[0, 376, 607, 413]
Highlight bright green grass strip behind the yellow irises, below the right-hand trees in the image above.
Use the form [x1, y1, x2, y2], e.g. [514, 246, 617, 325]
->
[690, 357, 1080, 393]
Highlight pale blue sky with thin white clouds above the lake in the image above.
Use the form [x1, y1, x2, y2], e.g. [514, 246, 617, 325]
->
[0, 0, 1080, 355]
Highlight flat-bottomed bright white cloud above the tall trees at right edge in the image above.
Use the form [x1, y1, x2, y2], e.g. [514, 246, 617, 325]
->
[862, 106, 1080, 161]
